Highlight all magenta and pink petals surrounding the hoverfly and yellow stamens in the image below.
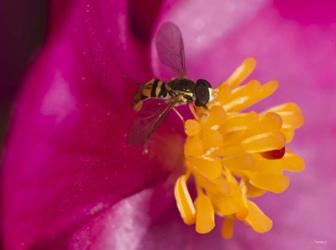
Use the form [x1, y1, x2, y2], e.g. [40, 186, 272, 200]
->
[1, 0, 336, 250]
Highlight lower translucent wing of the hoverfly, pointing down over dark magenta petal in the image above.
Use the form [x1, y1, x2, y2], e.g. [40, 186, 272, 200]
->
[128, 102, 176, 145]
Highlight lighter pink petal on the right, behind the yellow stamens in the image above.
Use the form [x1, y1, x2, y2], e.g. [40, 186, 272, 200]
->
[144, 1, 336, 249]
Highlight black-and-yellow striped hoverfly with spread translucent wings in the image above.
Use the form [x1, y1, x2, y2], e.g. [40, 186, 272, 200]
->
[128, 22, 212, 145]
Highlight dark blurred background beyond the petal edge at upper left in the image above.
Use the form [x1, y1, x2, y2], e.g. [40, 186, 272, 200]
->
[0, 0, 48, 145]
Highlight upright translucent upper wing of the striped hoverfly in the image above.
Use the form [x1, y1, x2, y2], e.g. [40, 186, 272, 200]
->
[155, 22, 186, 77]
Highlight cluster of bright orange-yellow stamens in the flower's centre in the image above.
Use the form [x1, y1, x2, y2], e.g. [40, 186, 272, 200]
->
[175, 58, 304, 239]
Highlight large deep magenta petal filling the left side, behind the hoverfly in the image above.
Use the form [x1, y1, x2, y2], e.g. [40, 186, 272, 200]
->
[4, 0, 177, 249]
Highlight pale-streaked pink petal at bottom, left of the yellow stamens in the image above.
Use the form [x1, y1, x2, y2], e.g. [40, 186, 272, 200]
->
[69, 184, 174, 250]
